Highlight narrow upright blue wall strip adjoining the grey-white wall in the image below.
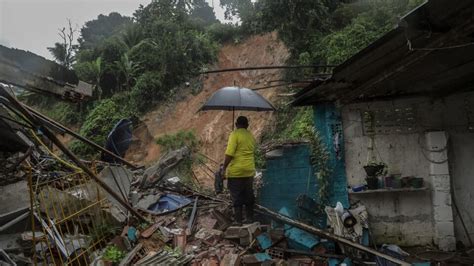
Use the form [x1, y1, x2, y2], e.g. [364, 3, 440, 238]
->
[313, 103, 349, 208]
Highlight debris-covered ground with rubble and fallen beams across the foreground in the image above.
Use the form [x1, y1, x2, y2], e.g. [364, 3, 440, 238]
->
[0, 86, 473, 265]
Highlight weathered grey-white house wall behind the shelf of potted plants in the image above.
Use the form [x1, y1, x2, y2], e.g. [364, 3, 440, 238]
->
[342, 93, 474, 245]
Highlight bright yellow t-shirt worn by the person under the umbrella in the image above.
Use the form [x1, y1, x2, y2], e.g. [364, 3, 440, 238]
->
[225, 128, 255, 178]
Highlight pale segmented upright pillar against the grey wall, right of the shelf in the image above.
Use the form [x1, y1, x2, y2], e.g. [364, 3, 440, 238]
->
[425, 131, 456, 251]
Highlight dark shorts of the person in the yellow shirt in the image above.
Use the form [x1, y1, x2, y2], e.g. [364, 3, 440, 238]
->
[227, 177, 254, 207]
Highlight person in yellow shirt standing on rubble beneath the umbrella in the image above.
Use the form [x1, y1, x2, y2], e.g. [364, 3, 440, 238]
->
[224, 116, 255, 224]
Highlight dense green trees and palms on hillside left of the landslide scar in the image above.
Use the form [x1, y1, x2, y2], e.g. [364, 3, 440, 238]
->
[36, 0, 222, 157]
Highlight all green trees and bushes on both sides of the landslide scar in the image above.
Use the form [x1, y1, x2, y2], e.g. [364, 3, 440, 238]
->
[34, 0, 421, 159]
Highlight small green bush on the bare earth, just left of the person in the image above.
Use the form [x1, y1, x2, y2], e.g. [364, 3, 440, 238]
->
[156, 130, 199, 152]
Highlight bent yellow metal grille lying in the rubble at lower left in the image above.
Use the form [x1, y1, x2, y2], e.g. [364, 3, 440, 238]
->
[28, 163, 120, 265]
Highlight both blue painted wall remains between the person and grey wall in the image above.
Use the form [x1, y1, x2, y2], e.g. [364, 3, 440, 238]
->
[258, 104, 349, 227]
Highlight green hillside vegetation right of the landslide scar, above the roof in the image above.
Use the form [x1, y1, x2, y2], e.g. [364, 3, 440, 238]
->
[221, 0, 423, 139]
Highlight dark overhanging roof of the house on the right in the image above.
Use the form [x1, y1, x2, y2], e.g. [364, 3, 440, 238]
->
[293, 0, 474, 106]
